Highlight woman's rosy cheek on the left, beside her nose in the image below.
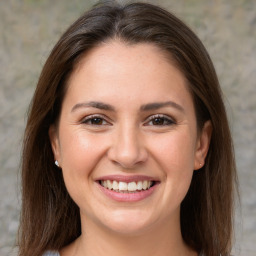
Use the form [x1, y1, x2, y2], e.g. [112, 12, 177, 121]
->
[60, 129, 107, 193]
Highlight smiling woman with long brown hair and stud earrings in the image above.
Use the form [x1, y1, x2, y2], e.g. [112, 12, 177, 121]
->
[19, 2, 236, 256]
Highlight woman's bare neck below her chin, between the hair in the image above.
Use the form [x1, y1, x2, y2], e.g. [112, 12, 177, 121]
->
[66, 214, 197, 256]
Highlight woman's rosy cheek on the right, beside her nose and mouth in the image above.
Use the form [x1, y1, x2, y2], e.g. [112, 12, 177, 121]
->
[149, 132, 195, 202]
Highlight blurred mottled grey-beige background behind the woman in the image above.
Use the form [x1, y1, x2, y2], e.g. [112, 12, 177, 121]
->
[0, 0, 256, 256]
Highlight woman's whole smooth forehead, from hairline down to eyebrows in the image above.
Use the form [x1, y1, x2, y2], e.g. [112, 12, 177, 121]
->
[64, 41, 194, 110]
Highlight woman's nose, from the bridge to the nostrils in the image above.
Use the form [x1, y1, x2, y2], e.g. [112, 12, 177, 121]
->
[108, 123, 148, 169]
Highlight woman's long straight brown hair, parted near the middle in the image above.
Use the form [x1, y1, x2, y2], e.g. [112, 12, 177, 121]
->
[19, 2, 236, 256]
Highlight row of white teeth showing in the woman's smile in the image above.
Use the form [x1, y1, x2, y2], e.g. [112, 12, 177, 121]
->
[100, 180, 153, 192]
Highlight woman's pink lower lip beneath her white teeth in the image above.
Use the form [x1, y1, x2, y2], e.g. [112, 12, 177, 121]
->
[98, 183, 158, 202]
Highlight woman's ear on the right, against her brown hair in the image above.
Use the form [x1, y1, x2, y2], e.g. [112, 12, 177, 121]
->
[194, 120, 212, 170]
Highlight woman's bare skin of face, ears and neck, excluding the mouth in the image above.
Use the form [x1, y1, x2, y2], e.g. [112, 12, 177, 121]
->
[49, 41, 211, 256]
